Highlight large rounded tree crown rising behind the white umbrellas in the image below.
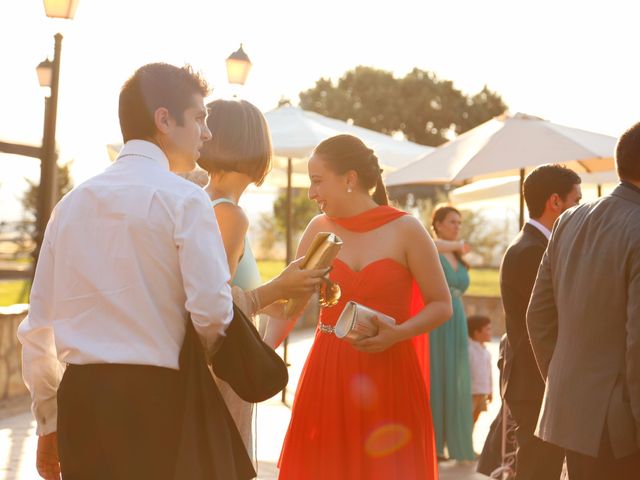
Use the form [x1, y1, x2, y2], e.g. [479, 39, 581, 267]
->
[300, 66, 507, 146]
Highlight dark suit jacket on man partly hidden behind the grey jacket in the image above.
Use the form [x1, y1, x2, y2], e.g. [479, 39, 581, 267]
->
[500, 223, 547, 404]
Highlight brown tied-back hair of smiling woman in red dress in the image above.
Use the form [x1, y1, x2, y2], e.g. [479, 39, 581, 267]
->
[313, 134, 389, 205]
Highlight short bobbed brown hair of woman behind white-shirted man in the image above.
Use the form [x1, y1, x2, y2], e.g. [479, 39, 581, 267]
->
[198, 100, 272, 186]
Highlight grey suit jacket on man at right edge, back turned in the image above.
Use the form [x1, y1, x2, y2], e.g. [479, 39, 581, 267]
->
[527, 184, 640, 458]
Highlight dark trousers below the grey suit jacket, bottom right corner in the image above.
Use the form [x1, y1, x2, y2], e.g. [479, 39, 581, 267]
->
[567, 427, 640, 480]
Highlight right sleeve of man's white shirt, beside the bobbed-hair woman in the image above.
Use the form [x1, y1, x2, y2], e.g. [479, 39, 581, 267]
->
[175, 191, 233, 350]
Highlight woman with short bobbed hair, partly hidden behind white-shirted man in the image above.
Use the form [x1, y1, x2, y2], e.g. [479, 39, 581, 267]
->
[198, 100, 326, 459]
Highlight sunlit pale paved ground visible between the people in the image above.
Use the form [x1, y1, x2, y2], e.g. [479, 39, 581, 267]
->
[0, 330, 500, 480]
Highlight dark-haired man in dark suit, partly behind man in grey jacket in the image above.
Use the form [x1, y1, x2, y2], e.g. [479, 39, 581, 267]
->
[500, 165, 582, 480]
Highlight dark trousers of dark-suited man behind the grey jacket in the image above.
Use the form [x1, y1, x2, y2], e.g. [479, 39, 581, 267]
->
[508, 401, 565, 480]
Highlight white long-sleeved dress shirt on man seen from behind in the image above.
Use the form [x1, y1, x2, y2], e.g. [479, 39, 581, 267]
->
[18, 140, 233, 435]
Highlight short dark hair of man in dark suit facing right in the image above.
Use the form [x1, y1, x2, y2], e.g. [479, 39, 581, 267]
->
[524, 164, 582, 218]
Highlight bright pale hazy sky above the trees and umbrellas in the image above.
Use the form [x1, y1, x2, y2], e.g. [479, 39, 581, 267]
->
[0, 0, 640, 220]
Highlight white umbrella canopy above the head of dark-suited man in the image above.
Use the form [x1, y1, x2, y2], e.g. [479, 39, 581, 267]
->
[386, 113, 616, 186]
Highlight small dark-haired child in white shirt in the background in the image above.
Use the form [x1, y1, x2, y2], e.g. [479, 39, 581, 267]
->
[467, 315, 492, 424]
